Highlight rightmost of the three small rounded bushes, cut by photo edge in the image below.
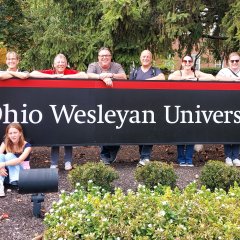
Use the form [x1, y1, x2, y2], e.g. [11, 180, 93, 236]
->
[200, 161, 240, 191]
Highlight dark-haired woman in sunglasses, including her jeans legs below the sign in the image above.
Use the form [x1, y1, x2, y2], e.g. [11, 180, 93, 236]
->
[168, 55, 216, 167]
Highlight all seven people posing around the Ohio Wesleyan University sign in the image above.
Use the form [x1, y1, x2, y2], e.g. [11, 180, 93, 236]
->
[0, 47, 240, 196]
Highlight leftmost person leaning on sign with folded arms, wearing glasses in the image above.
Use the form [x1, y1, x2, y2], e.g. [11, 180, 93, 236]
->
[0, 51, 29, 80]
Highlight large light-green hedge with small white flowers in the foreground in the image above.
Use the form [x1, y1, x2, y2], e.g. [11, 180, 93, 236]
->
[44, 184, 240, 240]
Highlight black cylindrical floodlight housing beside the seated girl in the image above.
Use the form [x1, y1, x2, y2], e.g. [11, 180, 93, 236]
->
[18, 168, 58, 194]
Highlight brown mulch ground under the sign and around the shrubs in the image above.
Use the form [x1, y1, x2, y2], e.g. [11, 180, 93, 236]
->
[0, 145, 224, 240]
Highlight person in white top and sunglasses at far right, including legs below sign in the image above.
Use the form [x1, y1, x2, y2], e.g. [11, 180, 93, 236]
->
[216, 52, 240, 167]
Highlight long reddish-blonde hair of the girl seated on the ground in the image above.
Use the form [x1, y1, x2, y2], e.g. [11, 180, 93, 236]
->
[4, 123, 25, 153]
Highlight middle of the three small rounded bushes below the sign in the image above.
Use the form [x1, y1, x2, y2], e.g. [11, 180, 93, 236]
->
[135, 161, 177, 189]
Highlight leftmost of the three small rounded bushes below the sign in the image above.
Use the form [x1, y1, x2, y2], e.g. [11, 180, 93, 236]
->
[68, 162, 119, 191]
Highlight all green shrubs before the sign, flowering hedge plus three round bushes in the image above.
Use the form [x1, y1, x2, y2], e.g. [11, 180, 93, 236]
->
[44, 161, 240, 240]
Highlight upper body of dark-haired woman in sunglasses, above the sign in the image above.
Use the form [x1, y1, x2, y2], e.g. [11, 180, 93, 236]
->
[168, 55, 216, 81]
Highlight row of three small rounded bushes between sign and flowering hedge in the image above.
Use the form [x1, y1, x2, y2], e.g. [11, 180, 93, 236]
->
[69, 161, 240, 191]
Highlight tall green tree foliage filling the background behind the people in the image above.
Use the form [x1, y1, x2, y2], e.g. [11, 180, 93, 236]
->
[0, 0, 240, 70]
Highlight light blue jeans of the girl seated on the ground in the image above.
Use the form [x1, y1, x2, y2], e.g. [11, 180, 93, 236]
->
[0, 153, 23, 183]
